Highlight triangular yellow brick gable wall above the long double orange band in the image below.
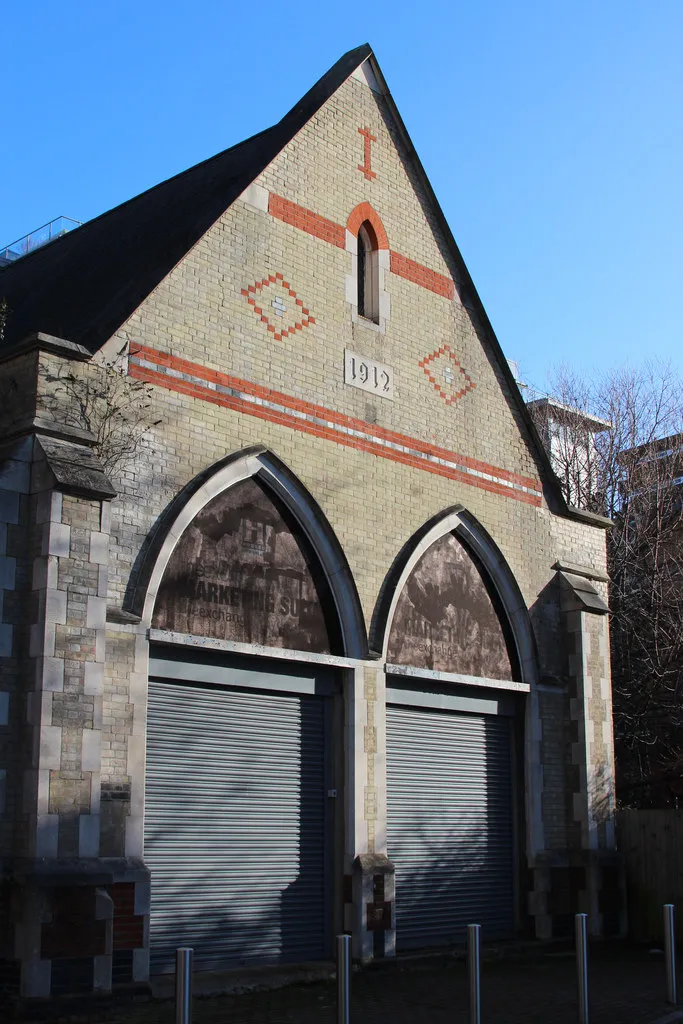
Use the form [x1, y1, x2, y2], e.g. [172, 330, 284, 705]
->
[100, 79, 537, 476]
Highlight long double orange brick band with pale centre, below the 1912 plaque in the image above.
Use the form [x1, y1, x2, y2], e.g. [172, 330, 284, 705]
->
[128, 345, 541, 506]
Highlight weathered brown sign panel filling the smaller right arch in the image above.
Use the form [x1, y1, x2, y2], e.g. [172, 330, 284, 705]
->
[388, 534, 513, 679]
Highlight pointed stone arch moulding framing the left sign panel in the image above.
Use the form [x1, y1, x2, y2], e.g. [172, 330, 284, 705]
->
[124, 446, 367, 657]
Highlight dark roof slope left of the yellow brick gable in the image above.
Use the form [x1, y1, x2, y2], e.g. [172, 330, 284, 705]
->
[0, 44, 371, 352]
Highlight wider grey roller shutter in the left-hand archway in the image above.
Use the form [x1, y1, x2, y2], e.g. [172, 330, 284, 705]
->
[144, 680, 329, 973]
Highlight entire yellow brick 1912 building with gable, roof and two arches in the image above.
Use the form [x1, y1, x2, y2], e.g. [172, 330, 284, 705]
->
[0, 46, 620, 997]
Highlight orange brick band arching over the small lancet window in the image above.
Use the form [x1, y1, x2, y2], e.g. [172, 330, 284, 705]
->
[268, 193, 456, 299]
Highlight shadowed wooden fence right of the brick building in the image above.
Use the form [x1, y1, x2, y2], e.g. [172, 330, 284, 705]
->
[616, 810, 683, 945]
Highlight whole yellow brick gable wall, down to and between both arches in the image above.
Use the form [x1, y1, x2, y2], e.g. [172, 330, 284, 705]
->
[93, 70, 604, 638]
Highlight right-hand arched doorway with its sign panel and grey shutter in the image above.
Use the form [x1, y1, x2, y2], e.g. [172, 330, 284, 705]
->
[384, 512, 528, 951]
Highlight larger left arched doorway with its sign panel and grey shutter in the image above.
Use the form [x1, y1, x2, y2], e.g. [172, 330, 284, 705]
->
[138, 453, 361, 973]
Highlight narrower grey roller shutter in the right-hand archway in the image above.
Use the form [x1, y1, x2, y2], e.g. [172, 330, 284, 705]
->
[387, 706, 514, 949]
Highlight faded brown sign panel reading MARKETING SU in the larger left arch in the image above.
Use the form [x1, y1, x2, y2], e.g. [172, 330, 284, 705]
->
[153, 479, 331, 652]
